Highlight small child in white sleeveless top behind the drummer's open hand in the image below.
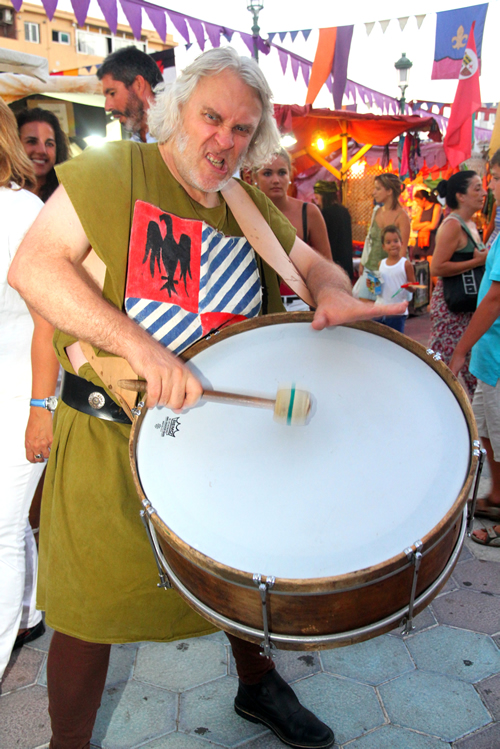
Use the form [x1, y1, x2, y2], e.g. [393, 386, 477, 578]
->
[376, 224, 416, 333]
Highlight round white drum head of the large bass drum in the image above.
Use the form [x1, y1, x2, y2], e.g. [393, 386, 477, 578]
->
[137, 323, 471, 579]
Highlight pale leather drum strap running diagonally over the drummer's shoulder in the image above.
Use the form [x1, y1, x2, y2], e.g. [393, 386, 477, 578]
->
[221, 179, 315, 307]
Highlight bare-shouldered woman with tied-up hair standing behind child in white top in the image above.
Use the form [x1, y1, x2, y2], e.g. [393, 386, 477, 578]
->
[355, 172, 410, 302]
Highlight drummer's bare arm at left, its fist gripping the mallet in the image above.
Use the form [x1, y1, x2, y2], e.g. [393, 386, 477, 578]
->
[8, 186, 202, 408]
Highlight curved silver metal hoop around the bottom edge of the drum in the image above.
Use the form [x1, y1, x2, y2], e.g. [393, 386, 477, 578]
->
[140, 508, 467, 650]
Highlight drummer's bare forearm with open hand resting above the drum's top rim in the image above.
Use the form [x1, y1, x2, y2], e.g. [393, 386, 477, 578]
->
[290, 239, 407, 330]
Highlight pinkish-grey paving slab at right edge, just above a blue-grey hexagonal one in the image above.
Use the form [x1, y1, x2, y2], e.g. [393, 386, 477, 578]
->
[432, 589, 500, 635]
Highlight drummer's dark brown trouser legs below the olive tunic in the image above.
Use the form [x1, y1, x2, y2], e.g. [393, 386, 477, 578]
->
[47, 632, 274, 749]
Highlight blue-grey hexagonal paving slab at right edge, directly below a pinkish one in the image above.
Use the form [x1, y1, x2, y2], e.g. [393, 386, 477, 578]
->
[406, 627, 500, 684]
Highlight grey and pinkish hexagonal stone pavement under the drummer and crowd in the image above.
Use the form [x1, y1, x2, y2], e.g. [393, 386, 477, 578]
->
[0, 317, 500, 749]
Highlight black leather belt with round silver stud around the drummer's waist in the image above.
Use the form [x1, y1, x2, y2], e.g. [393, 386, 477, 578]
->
[59, 371, 132, 424]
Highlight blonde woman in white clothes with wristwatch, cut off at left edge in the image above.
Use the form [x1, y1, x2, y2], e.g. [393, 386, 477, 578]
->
[0, 99, 59, 678]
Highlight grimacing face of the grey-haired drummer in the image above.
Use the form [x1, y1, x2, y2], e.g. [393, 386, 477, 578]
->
[166, 70, 262, 193]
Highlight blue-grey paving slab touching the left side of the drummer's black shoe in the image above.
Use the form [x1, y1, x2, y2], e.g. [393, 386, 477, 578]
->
[179, 676, 269, 748]
